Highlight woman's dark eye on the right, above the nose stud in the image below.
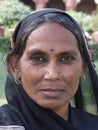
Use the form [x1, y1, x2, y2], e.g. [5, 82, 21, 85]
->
[59, 55, 74, 64]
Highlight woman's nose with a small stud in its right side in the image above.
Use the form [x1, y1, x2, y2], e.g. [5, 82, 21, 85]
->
[44, 63, 62, 80]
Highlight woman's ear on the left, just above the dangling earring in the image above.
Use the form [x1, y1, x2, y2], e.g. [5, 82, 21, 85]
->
[10, 56, 20, 77]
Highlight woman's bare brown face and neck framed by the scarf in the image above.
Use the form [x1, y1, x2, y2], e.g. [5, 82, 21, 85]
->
[14, 22, 85, 120]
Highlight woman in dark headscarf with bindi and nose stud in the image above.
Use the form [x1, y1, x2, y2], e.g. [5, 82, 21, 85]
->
[0, 9, 98, 130]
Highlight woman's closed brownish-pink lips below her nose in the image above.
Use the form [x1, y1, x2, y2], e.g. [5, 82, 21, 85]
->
[40, 89, 64, 98]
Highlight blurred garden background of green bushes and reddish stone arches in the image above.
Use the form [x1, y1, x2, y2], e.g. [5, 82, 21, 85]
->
[0, 0, 98, 112]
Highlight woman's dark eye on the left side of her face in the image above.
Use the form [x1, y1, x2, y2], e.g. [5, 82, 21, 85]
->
[32, 55, 47, 64]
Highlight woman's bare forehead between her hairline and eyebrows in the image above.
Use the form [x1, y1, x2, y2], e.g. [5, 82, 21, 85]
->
[26, 22, 78, 52]
